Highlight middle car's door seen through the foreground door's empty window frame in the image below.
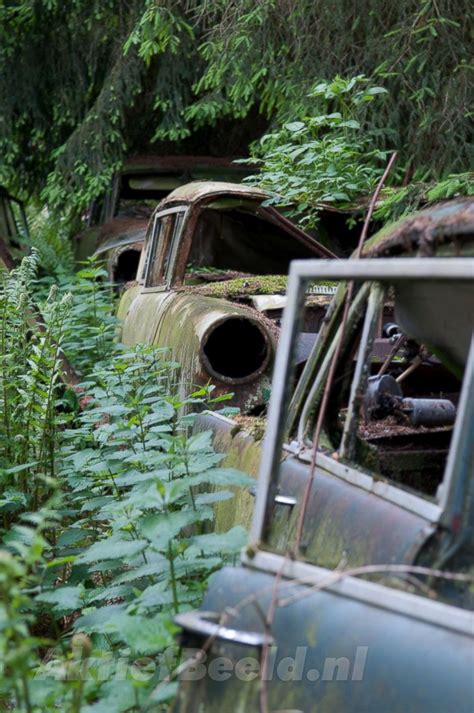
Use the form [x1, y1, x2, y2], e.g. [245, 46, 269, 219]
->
[254, 260, 472, 568]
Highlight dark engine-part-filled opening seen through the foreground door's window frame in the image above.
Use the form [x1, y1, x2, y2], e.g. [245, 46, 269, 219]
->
[309, 286, 461, 498]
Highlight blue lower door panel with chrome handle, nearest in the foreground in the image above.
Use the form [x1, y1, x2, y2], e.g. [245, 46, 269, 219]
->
[172, 567, 474, 713]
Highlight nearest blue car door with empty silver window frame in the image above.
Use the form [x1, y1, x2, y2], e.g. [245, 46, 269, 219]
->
[174, 261, 474, 713]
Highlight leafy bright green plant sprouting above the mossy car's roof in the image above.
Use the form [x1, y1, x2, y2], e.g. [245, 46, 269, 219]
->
[245, 75, 387, 228]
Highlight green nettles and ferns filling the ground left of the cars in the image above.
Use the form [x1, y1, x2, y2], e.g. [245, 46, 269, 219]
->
[0, 255, 253, 713]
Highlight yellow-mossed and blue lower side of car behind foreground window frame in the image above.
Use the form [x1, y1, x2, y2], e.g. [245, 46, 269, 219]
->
[195, 414, 434, 568]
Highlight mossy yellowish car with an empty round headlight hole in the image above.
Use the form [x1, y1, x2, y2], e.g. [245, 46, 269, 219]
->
[118, 181, 332, 413]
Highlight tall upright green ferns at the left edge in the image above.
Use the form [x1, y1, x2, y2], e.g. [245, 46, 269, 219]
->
[0, 252, 70, 530]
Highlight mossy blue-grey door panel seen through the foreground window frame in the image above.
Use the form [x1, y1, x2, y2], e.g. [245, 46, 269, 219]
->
[265, 456, 434, 569]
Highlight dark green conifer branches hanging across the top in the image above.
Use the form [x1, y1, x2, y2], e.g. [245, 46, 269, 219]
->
[0, 0, 474, 214]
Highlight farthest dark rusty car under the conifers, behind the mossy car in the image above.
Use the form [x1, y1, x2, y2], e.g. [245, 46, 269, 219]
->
[75, 155, 251, 284]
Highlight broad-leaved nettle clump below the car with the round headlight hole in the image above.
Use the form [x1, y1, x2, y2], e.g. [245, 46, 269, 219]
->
[29, 346, 253, 711]
